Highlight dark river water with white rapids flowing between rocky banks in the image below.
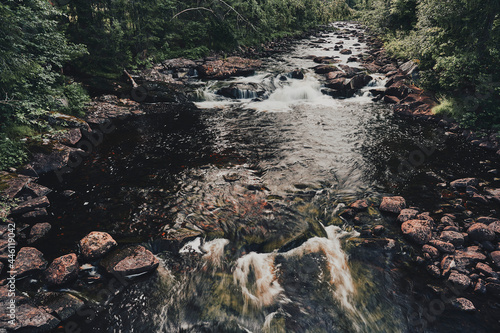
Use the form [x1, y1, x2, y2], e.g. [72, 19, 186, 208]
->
[44, 25, 500, 332]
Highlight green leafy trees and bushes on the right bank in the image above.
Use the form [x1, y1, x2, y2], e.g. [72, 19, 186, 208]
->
[362, 0, 500, 128]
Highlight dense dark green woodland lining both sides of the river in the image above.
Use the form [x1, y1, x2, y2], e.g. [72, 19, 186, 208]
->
[0, 0, 500, 169]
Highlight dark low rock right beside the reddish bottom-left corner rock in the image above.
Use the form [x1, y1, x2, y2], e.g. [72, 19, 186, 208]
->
[36, 292, 85, 320]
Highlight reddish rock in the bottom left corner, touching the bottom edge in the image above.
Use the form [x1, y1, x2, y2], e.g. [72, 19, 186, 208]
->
[9, 304, 60, 332]
